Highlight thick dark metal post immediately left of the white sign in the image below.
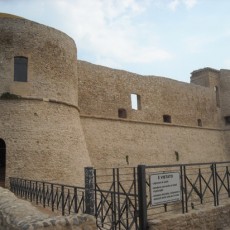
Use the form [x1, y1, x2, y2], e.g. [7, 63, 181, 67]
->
[137, 165, 148, 230]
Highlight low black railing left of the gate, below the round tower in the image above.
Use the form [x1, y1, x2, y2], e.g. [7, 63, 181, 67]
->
[10, 177, 85, 215]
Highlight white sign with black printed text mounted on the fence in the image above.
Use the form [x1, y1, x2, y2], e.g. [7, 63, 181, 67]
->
[150, 172, 181, 206]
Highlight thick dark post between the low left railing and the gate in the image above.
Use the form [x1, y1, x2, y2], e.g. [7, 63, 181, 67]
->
[85, 167, 95, 215]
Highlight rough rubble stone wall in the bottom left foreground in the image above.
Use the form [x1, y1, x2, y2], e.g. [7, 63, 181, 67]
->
[0, 187, 97, 230]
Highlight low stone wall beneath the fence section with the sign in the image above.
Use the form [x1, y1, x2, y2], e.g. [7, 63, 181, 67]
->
[149, 202, 230, 230]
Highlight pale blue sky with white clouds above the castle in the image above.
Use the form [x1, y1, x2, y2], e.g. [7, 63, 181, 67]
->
[0, 0, 230, 82]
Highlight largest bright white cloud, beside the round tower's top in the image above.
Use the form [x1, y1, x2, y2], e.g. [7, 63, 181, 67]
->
[52, 0, 171, 66]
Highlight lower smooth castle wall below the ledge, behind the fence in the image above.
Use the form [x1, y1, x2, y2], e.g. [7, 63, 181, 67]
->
[81, 117, 229, 168]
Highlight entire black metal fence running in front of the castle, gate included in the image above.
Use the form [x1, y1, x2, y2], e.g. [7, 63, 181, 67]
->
[10, 162, 230, 230]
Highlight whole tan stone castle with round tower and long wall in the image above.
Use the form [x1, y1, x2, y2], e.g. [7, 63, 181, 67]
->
[0, 14, 230, 185]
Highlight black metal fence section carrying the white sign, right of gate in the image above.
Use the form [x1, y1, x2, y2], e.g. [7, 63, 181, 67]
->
[138, 162, 230, 229]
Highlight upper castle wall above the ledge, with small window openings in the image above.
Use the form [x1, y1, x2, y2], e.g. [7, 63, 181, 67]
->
[78, 61, 220, 128]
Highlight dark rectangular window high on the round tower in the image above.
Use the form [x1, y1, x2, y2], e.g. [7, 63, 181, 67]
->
[14, 57, 28, 82]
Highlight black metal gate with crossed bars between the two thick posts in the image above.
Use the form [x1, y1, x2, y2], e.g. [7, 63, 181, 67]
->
[91, 168, 139, 230]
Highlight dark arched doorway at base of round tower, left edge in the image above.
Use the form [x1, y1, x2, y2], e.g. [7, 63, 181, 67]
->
[0, 138, 6, 187]
